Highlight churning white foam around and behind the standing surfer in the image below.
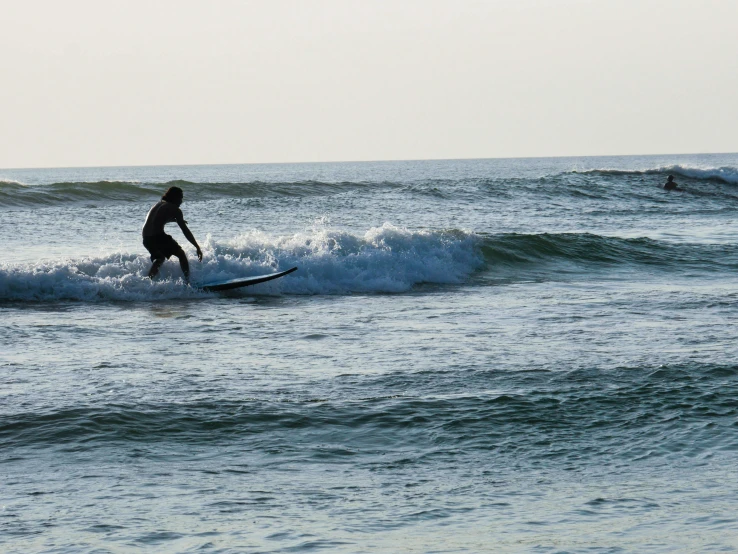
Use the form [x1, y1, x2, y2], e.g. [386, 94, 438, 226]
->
[0, 223, 484, 301]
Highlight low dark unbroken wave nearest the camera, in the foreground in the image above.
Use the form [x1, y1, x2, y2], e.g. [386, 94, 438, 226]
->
[0, 365, 738, 452]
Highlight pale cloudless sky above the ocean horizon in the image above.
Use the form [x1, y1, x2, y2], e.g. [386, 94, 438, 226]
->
[0, 0, 738, 168]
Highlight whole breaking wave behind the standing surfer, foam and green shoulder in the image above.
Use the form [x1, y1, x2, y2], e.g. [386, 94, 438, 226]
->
[0, 223, 738, 302]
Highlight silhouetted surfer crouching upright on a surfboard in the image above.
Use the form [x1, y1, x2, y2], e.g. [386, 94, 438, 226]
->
[141, 187, 202, 281]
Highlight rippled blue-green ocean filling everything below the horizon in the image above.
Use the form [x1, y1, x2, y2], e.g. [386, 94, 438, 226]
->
[0, 154, 738, 553]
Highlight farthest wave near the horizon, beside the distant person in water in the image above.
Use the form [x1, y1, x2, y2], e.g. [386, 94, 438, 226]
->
[0, 165, 738, 207]
